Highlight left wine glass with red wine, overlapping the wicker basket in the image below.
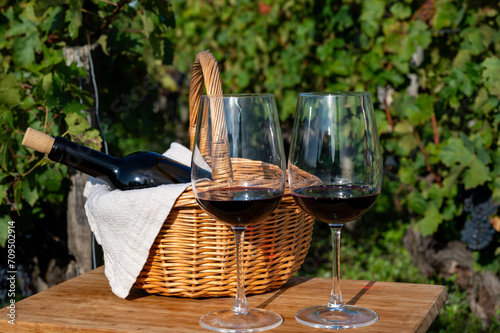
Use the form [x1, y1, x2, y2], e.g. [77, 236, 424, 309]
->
[191, 94, 286, 332]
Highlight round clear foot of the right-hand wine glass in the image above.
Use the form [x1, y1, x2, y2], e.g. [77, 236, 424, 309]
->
[295, 305, 378, 330]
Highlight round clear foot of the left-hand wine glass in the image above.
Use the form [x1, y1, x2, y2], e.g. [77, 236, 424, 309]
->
[200, 309, 283, 332]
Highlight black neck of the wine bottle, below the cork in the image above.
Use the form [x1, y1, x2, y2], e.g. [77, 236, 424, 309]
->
[48, 137, 120, 178]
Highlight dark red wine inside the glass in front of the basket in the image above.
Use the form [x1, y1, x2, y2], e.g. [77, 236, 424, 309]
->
[196, 187, 283, 227]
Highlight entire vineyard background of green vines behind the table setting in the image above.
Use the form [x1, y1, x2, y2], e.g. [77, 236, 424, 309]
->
[0, 0, 500, 332]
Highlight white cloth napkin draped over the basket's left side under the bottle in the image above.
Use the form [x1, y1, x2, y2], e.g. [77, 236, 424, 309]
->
[83, 143, 191, 298]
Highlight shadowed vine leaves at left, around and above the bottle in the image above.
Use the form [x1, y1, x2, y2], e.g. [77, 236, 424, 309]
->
[0, 0, 182, 246]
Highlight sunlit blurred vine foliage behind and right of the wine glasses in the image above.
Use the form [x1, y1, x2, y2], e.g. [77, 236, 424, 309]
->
[165, 0, 500, 331]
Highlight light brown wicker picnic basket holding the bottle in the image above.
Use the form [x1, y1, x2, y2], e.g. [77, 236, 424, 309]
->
[134, 51, 313, 298]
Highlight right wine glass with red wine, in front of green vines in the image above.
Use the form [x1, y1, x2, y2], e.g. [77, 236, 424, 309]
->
[288, 92, 382, 329]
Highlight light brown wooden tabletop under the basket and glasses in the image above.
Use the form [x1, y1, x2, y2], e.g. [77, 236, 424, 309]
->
[0, 267, 448, 333]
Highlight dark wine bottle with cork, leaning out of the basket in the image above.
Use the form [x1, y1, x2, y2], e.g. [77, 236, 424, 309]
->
[22, 128, 191, 190]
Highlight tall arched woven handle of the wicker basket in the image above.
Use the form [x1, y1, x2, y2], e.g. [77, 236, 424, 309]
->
[189, 51, 232, 181]
